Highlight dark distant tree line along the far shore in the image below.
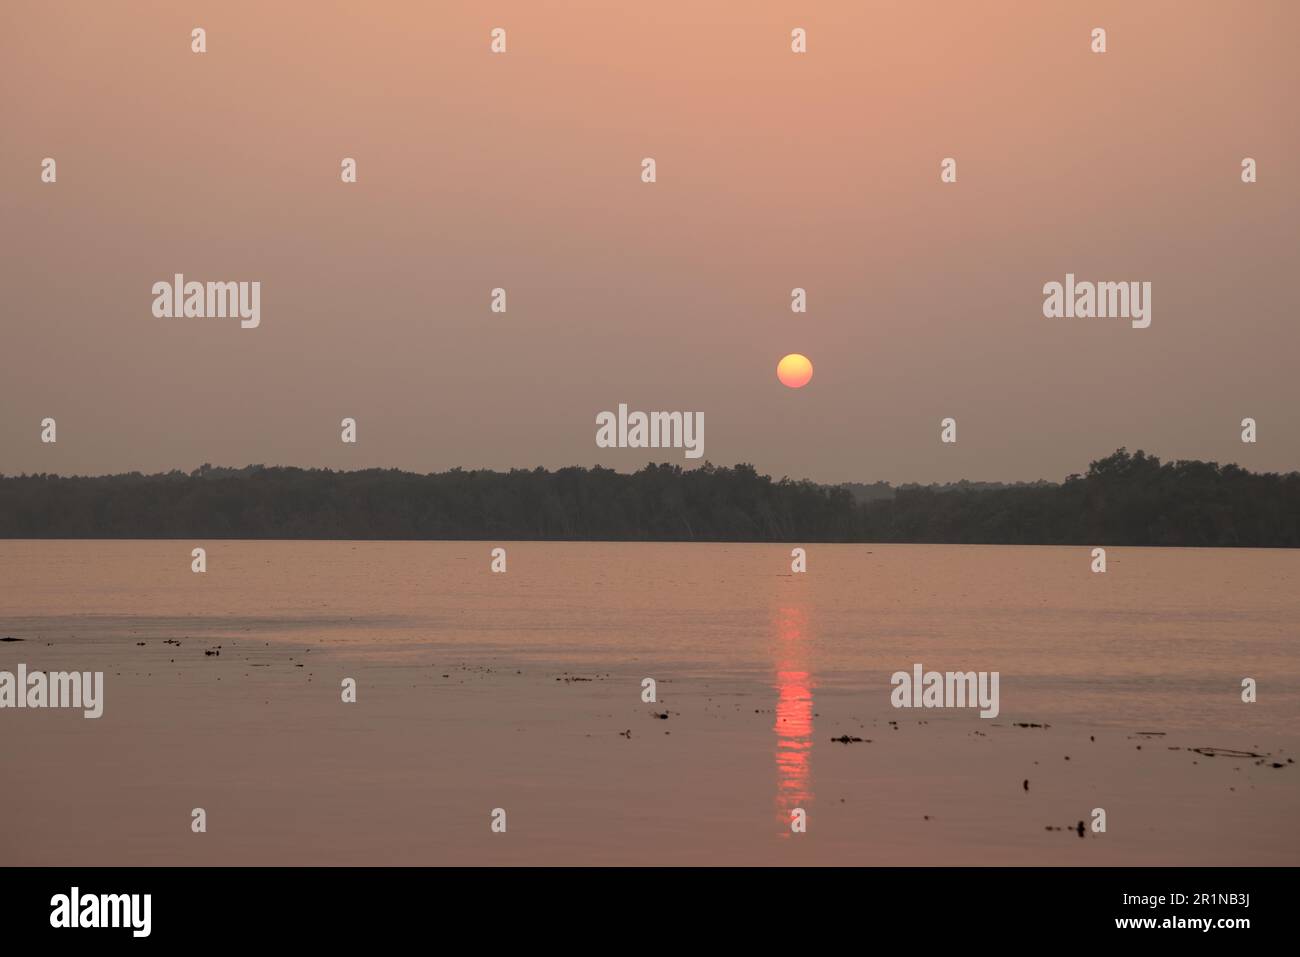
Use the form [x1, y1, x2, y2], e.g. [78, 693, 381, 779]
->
[0, 449, 1300, 547]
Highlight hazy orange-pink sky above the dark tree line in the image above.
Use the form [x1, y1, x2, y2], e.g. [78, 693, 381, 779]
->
[0, 0, 1300, 481]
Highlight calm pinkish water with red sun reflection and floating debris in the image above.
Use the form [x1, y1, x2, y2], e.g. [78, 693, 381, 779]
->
[0, 541, 1300, 863]
